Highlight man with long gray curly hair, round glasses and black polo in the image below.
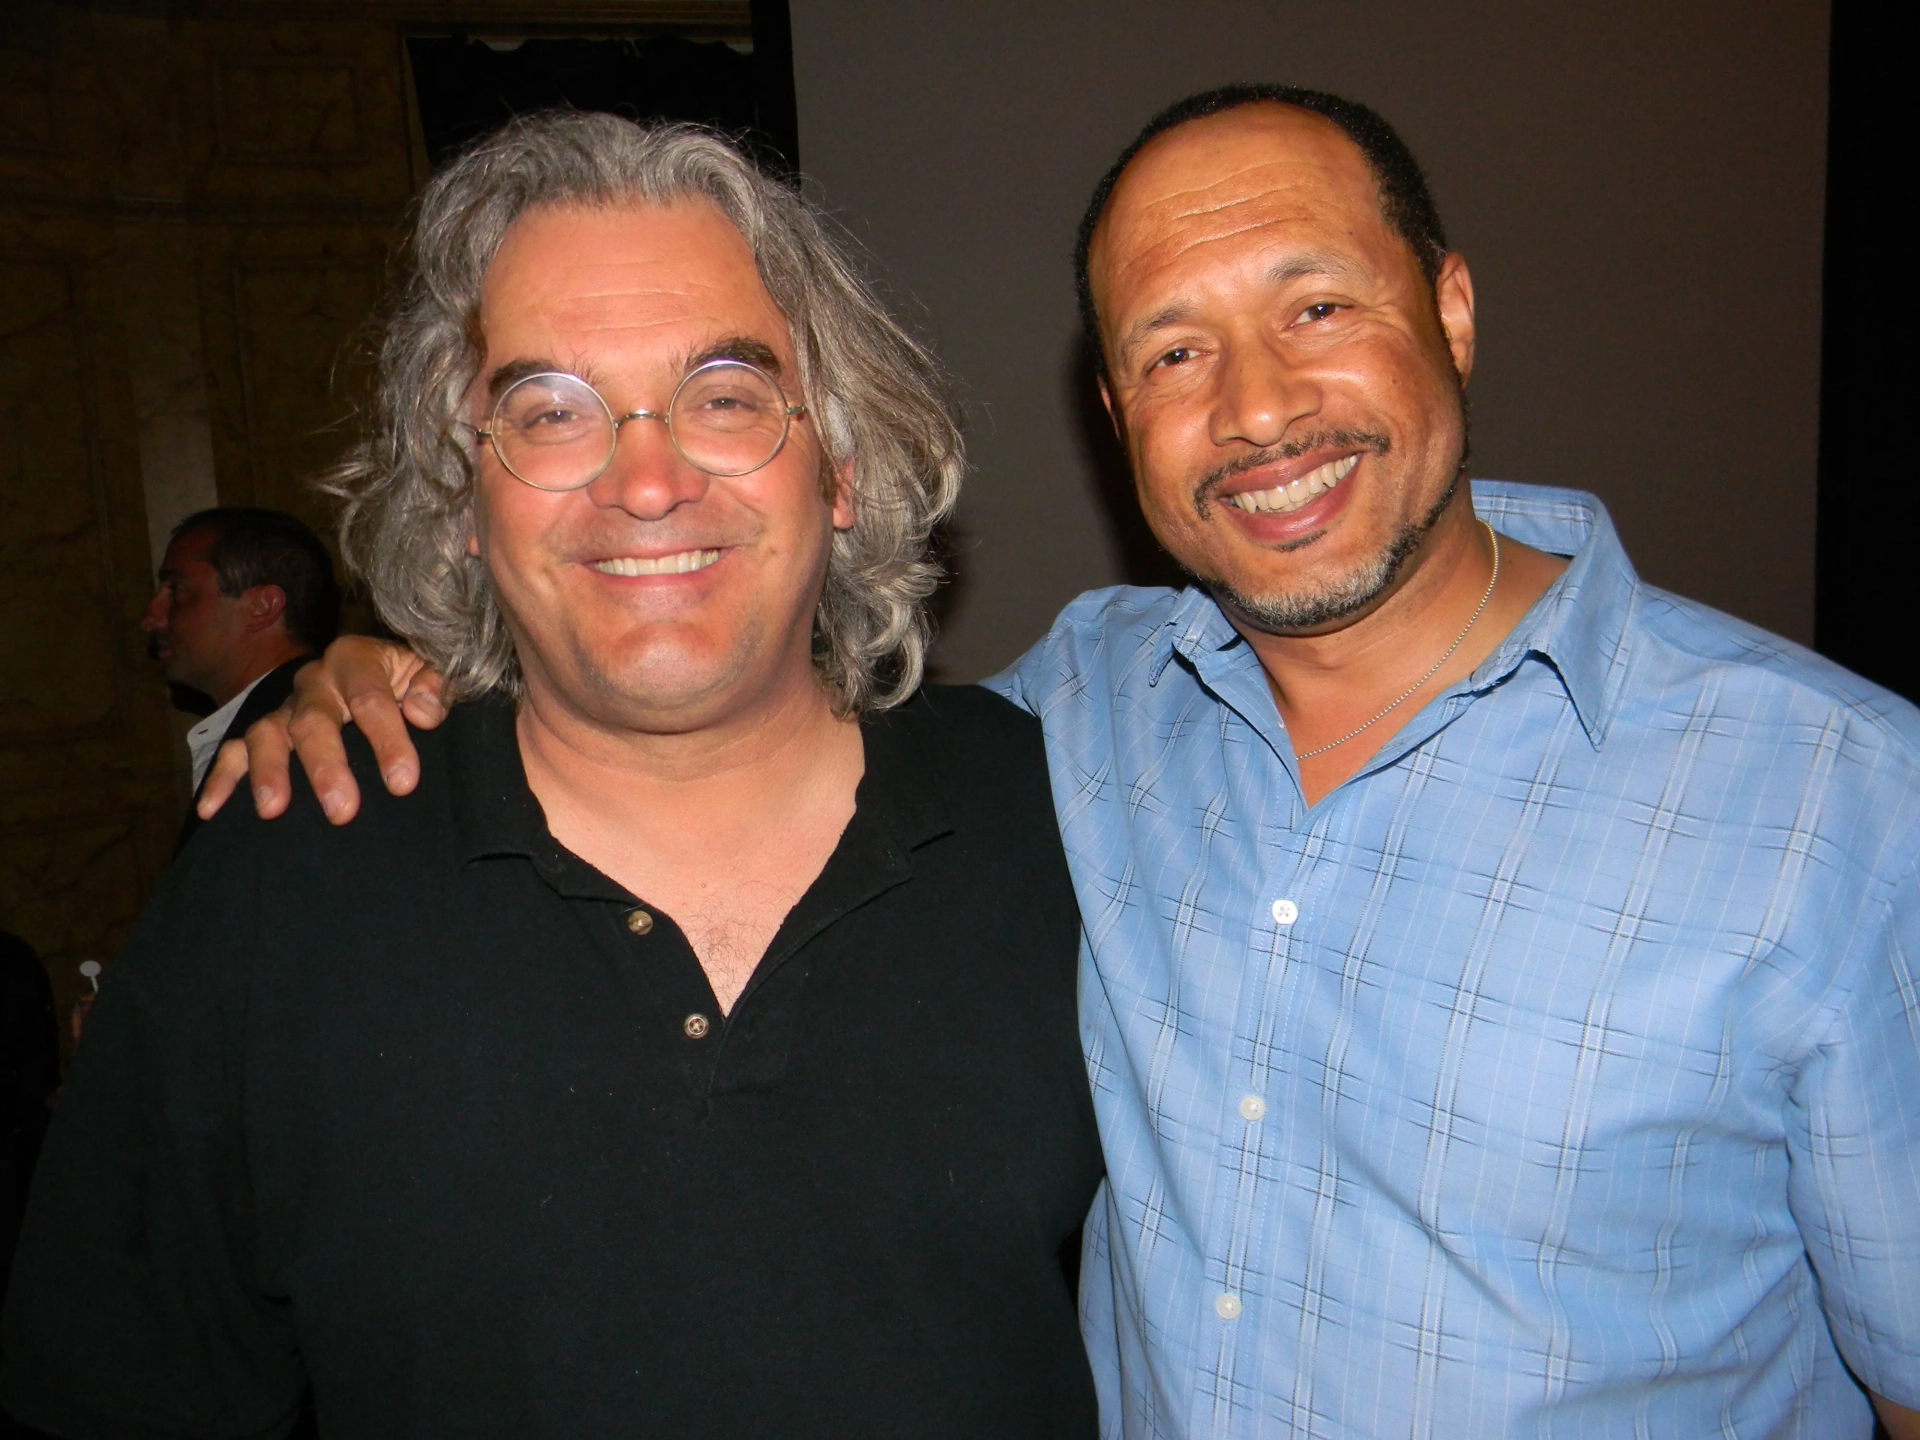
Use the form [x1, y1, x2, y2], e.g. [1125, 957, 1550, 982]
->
[4, 115, 1102, 1440]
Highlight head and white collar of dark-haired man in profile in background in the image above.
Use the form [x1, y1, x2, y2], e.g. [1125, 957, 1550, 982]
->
[140, 505, 340, 802]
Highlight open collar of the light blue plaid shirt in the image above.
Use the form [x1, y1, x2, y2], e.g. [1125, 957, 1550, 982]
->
[1146, 480, 1640, 749]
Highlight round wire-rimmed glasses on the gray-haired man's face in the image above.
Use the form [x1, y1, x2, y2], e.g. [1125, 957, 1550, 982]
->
[474, 359, 806, 490]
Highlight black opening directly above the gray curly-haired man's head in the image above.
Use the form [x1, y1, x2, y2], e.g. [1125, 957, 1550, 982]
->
[407, 0, 799, 177]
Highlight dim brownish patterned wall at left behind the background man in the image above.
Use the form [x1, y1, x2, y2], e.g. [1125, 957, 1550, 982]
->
[0, 6, 420, 1036]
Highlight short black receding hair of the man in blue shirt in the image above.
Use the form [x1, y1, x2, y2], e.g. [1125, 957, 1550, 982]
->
[1073, 84, 1448, 374]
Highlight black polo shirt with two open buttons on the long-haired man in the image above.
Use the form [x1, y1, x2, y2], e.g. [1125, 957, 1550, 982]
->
[4, 687, 1100, 1440]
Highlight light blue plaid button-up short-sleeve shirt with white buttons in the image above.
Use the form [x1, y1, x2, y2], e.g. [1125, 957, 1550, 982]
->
[991, 484, 1920, 1440]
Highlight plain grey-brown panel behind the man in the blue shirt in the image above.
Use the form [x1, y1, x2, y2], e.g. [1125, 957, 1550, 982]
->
[791, 0, 1828, 680]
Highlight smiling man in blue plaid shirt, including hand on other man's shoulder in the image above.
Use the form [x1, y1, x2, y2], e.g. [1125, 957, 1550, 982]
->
[194, 86, 1920, 1440]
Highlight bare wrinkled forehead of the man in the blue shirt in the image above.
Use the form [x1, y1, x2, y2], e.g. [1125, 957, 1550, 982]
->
[1087, 102, 1384, 311]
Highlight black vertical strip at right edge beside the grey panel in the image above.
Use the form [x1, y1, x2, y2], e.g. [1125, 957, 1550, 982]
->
[1814, 0, 1920, 701]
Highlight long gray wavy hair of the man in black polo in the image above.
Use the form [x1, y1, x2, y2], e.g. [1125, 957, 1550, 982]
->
[321, 113, 966, 714]
